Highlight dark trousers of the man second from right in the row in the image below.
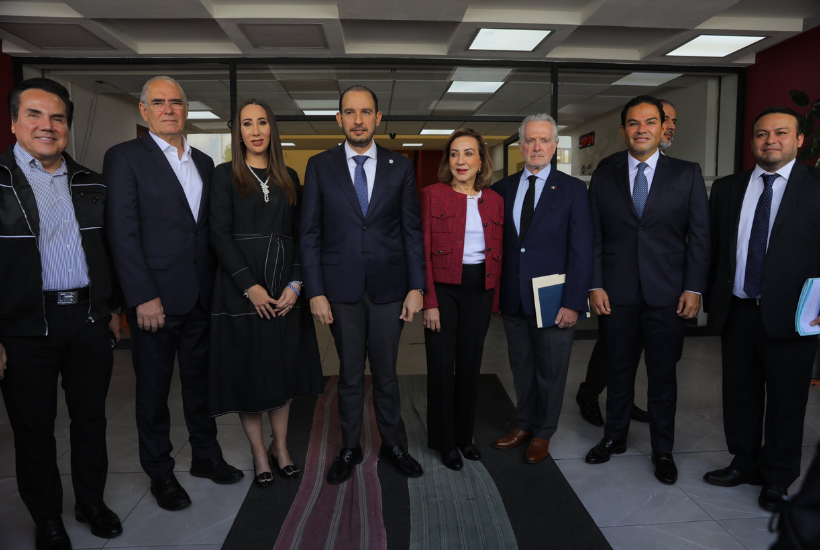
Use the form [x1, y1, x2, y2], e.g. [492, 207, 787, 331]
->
[599, 291, 686, 453]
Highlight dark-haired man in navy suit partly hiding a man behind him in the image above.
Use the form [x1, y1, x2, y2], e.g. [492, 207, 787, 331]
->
[586, 96, 710, 484]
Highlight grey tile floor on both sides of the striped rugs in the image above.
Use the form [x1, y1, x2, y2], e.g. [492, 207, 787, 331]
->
[0, 319, 820, 550]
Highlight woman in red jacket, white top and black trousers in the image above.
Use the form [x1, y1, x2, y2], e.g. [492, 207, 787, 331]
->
[421, 128, 504, 470]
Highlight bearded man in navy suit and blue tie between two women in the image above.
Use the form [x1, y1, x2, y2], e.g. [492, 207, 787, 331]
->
[300, 86, 426, 484]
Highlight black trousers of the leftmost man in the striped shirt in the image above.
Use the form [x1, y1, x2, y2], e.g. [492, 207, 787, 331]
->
[0, 301, 114, 523]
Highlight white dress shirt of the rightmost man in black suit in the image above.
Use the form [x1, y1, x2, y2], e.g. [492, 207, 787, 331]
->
[732, 160, 795, 298]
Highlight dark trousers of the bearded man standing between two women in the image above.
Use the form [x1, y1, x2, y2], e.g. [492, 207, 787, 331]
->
[330, 291, 404, 449]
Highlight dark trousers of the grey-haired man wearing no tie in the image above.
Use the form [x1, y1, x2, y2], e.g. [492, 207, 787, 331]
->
[128, 305, 222, 478]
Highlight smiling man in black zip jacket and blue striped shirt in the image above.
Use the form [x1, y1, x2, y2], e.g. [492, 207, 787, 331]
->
[0, 78, 122, 549]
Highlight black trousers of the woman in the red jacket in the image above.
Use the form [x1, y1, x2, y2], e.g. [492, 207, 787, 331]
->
[424, 263, 494, 452]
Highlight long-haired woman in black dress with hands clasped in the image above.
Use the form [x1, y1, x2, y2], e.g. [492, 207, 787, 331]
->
[209, 99, 323, 487]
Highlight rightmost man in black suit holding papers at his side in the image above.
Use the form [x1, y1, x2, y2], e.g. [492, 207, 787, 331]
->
[703, 107, 820, 511]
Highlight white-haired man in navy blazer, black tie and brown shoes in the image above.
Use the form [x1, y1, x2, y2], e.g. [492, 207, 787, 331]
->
[493, 114, 592, 464]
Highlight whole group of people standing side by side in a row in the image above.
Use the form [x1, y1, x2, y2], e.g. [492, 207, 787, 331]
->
[0, 77, 820, 549]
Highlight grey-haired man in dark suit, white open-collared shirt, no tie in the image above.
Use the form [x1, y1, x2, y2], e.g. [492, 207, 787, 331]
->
[103, 77, 243, 510]
